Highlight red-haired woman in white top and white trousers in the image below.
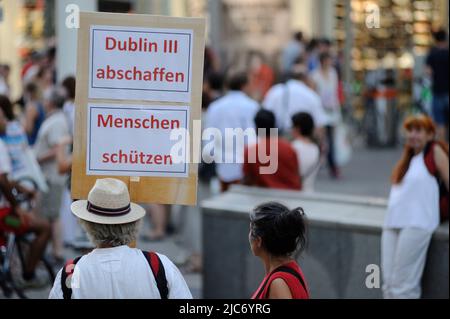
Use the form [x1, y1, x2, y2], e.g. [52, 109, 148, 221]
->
[381, 115, 449, 299]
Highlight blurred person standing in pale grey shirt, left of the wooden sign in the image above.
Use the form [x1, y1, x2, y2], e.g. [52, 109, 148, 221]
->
[34, 88, 69, 262]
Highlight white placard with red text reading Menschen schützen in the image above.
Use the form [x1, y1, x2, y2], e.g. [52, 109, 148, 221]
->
[86, 104, 189, 177]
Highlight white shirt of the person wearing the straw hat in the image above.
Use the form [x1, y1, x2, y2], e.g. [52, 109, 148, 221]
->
[49, 246, 192, 299]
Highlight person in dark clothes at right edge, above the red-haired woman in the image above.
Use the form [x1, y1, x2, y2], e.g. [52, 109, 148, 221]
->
[426, 30, 449, 142]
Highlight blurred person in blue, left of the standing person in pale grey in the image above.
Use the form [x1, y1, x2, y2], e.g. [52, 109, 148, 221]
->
[24, 82, 45, 145]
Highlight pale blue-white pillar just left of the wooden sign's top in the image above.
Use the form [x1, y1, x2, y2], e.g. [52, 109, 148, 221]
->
[55, 0, 97, 81]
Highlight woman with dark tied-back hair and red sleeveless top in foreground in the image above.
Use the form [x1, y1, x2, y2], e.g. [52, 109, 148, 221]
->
[249, 202, 309, 299]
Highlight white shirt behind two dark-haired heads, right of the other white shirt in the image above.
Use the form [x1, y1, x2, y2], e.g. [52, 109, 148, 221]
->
[263, 80, 328, 130]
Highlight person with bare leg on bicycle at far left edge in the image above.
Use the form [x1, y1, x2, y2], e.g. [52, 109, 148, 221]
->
[0, 108, 50, 288]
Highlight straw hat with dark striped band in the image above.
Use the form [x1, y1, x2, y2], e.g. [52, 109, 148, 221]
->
[70, 178, 145, 225]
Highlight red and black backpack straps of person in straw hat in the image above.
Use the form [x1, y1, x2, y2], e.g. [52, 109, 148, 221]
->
[61, 250, 169, 299]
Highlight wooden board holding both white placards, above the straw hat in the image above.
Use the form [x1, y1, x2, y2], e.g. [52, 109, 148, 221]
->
[72, 12, 205, 205]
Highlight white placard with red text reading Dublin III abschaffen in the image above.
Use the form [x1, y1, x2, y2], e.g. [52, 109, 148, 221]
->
[89, 25, 194, 103]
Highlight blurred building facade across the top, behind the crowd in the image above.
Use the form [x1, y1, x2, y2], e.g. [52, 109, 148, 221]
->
[0, 0, 448, 100]
